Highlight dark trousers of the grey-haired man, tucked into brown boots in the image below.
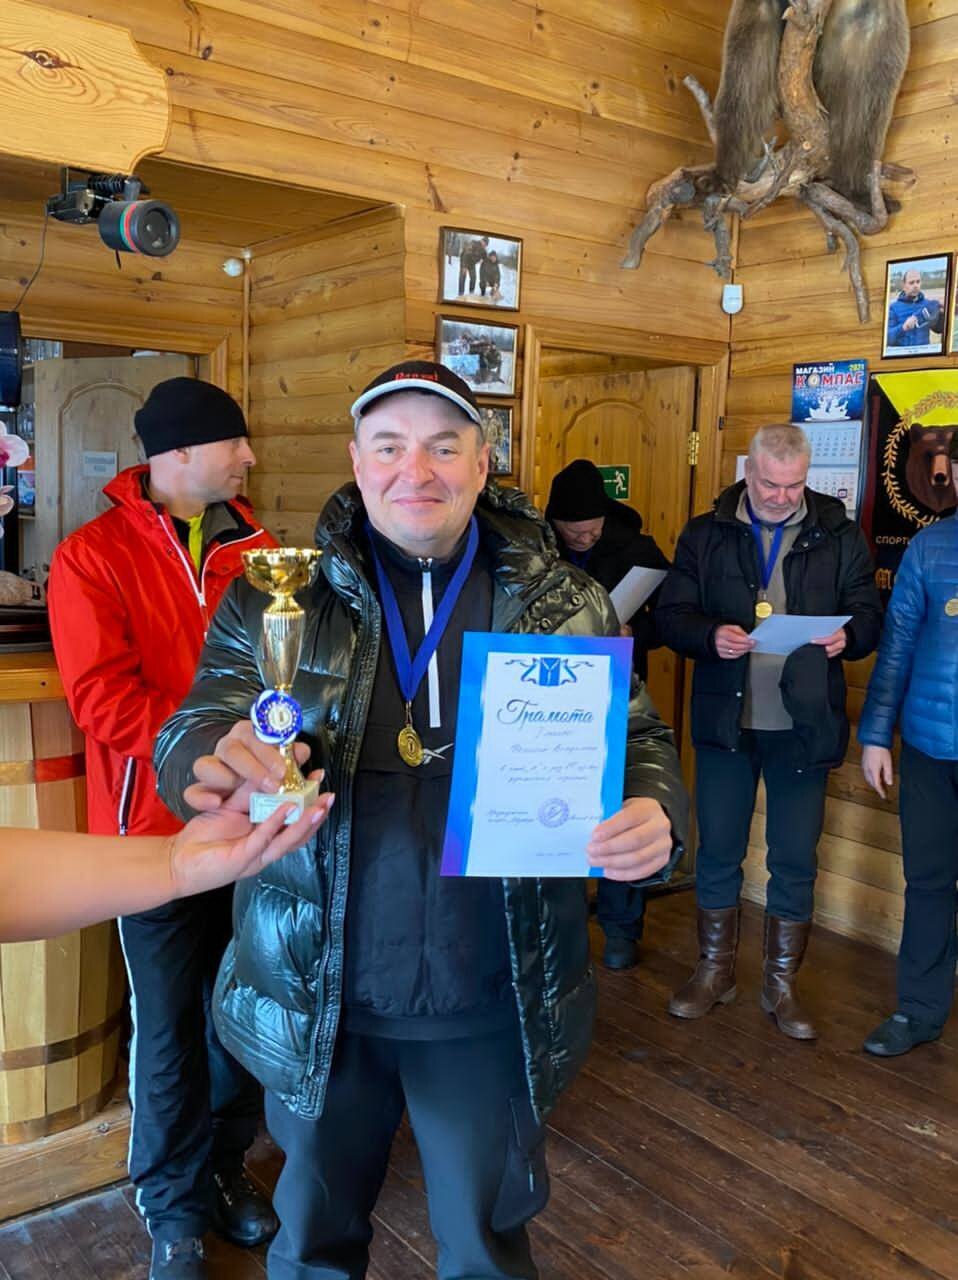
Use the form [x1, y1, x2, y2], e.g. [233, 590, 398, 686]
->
[695, 730, 829, 920]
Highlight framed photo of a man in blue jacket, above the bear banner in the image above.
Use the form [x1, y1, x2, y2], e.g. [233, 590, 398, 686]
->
[881, 253, 952, 360]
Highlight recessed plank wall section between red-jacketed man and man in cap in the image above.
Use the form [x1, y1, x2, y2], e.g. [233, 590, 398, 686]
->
[250, 207, 405, 547]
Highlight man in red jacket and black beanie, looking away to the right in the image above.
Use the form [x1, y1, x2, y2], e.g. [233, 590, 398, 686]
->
[49, 378, 277, 1280]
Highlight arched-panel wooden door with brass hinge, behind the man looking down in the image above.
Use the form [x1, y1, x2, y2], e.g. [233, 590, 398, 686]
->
[534, 366, 697, 740]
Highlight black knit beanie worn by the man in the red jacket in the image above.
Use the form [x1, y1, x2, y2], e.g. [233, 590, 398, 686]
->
[133, 378, 250, 458]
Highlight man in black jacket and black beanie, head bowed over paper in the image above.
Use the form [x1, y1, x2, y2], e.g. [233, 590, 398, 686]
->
[546, 458, 669, 969]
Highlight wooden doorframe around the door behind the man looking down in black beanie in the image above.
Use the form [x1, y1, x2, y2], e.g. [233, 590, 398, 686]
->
[519, 324, 731, 803]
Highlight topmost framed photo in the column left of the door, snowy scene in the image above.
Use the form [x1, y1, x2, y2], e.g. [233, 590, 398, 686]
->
[439, 227, 523, 311]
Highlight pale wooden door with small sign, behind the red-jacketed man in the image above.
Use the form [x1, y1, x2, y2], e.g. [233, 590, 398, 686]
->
[24, 356, 193, 566]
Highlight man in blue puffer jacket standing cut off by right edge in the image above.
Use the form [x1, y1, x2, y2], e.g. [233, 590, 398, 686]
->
[858, 516, 958, 1057]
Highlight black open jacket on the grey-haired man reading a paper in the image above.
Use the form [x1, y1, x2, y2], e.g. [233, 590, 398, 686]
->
[656, 481, 881, 768]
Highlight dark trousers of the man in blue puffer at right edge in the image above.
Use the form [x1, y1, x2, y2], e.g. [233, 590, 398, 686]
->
[898, 742, 958, 1028]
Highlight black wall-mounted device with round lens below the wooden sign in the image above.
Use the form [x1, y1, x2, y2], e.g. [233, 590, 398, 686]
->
[46, 169, 179, 257]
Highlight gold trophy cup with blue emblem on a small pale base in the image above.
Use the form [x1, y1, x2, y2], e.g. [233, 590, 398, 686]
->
[243, 547, 321, 823]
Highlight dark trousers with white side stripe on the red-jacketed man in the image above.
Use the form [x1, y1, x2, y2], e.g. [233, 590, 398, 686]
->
[119, 888, 261, 1240]
